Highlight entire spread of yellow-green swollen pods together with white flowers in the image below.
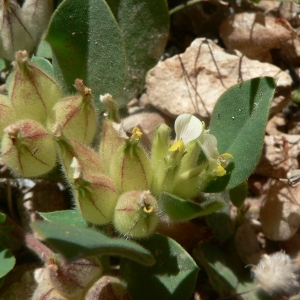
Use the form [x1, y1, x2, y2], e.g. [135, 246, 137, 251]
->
[0, 51, 232, 238]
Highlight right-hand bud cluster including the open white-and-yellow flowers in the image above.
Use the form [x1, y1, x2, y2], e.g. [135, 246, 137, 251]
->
[68, 94, 232, 238]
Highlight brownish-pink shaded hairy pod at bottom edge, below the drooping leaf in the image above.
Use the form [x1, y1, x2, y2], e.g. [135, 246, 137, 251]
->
[47, 258, 102, 299]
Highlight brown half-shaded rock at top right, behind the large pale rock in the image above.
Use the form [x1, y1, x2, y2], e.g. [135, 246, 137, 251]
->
[219, 12, 293, 60]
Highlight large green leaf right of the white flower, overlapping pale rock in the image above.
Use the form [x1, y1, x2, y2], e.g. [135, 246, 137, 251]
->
[207, 77, 276, 192]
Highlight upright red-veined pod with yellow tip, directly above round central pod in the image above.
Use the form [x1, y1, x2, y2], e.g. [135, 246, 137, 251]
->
[110, 128, 152, 192]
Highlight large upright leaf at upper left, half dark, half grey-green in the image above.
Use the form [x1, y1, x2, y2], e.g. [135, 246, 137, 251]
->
[45, 0, 125, 103]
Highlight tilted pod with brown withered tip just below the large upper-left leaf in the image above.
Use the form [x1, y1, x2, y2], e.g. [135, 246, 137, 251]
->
[48, 79, 97, 145]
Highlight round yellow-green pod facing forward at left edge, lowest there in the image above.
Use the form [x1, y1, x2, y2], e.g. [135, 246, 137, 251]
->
[1, 120, 56, 177]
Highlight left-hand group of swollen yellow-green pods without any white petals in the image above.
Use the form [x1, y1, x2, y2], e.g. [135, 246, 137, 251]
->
[0, 51, 97, 177]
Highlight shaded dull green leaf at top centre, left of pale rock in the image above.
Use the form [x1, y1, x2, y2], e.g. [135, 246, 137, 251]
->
[106, 0, 169, 104]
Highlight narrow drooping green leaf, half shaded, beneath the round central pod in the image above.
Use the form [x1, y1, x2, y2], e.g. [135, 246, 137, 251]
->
[31, 221, 155, 265]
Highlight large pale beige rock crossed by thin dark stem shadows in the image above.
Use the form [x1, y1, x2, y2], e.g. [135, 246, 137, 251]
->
[146, 38, 291, 121]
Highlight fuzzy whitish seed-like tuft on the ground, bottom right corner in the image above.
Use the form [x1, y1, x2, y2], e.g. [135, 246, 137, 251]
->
[252, 252, 298, 294]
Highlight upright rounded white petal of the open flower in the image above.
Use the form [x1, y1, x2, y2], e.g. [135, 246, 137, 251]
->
[174, 114, 203, 145]
